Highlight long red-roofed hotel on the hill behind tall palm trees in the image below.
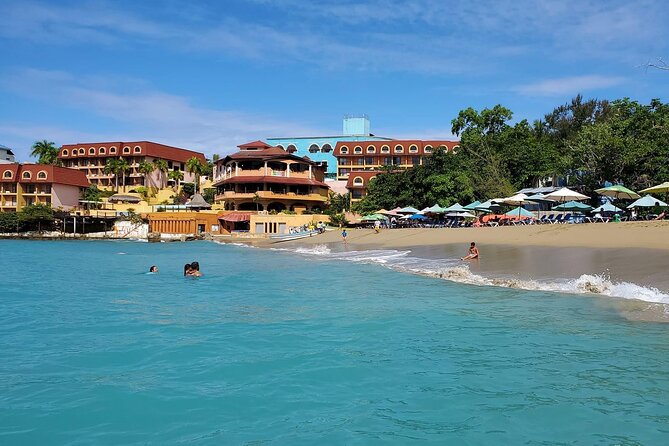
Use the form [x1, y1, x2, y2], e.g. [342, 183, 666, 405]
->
[58, 141, 206, 192]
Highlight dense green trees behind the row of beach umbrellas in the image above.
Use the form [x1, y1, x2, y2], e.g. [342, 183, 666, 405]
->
[354, 96, 669, 213]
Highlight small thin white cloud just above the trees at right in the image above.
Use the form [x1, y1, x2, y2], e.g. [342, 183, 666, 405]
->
[513, 75, 625, 96]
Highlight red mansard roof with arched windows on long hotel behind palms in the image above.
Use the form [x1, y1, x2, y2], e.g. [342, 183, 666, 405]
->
[58, 141, 206, 163]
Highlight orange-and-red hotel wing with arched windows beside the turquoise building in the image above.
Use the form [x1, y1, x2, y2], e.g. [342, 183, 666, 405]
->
[334, 140, 460, 180]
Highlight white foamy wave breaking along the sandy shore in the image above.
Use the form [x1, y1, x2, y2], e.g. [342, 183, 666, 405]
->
[278, 245, 669, 305]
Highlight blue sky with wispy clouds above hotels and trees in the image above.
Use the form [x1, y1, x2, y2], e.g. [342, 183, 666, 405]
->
[0, 0, 669, 161]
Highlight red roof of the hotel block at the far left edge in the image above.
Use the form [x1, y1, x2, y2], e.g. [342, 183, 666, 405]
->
[0, 164, 90, 187]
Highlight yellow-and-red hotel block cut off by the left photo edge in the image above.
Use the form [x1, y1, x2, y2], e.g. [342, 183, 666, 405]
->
[0, 164, 89, 212]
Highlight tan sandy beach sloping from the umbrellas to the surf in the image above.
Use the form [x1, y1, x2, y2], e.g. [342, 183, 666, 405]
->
[274, 221, 669, 322]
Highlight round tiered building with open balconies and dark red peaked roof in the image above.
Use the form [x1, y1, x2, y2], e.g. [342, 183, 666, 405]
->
[214, 141, 329, 213]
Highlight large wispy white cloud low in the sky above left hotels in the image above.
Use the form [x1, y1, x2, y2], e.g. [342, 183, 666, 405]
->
[0, 69, 323, 160]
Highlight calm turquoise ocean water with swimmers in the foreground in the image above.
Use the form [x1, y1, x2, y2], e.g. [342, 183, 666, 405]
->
[0, 241, 669, 445]
